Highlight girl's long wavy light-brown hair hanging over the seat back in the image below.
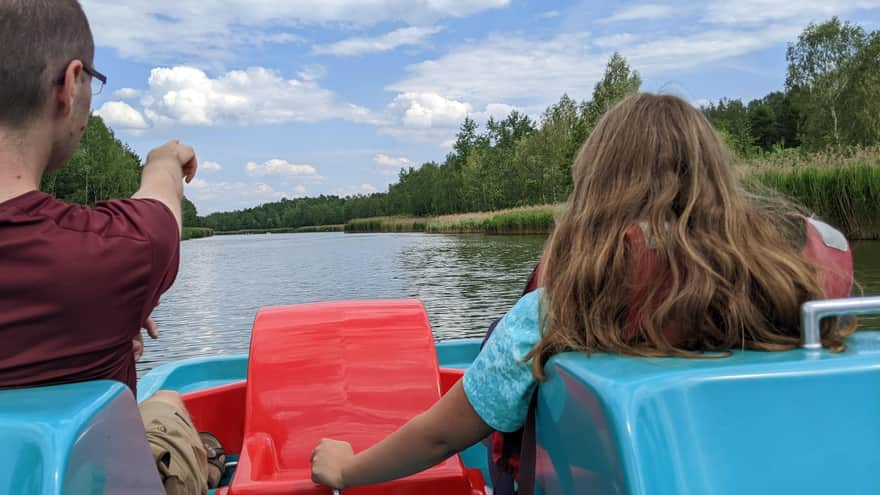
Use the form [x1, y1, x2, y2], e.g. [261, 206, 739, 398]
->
[526, 94, 843, 379]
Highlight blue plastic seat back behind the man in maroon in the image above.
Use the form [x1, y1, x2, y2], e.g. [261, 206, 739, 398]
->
[0, 381, 165, 495]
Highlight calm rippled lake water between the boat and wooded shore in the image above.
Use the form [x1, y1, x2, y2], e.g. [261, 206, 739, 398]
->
[138, 233, 880, 374]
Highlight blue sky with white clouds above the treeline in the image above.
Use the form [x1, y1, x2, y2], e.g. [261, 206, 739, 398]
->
[82, 0, 880, 214]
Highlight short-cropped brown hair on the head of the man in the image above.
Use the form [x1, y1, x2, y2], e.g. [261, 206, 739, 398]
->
[0, 0, 95, 127]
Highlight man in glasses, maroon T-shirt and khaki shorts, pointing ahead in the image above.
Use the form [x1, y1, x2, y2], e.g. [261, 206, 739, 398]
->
[0, 0, 217, 493]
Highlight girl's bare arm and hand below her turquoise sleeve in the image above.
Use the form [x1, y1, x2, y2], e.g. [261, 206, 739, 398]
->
[312, 381, 492, 489]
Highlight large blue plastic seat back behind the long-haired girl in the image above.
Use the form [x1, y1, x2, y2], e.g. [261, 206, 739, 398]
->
[536, 332, 880, 495]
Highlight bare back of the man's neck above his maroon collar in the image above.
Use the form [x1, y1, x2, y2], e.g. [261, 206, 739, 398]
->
[0, 126, 51, 203]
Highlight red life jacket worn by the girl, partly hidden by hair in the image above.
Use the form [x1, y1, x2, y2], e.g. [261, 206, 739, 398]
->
[486, 218, 853, 495]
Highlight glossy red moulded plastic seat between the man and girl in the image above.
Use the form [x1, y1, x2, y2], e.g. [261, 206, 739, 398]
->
[229, 301, 483, 495]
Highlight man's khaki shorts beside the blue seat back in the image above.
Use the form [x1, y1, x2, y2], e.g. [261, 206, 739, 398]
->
[139, 399, 208, 495]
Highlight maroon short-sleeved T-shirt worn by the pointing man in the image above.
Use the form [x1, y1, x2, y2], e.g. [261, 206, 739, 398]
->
[0, 191, 180, 392]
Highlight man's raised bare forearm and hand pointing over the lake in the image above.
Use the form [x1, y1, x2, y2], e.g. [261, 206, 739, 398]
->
[132, 139, 198, 230]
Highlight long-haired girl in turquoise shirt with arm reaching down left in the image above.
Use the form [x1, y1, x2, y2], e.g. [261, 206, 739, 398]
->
[312, 94, 852, 488]
